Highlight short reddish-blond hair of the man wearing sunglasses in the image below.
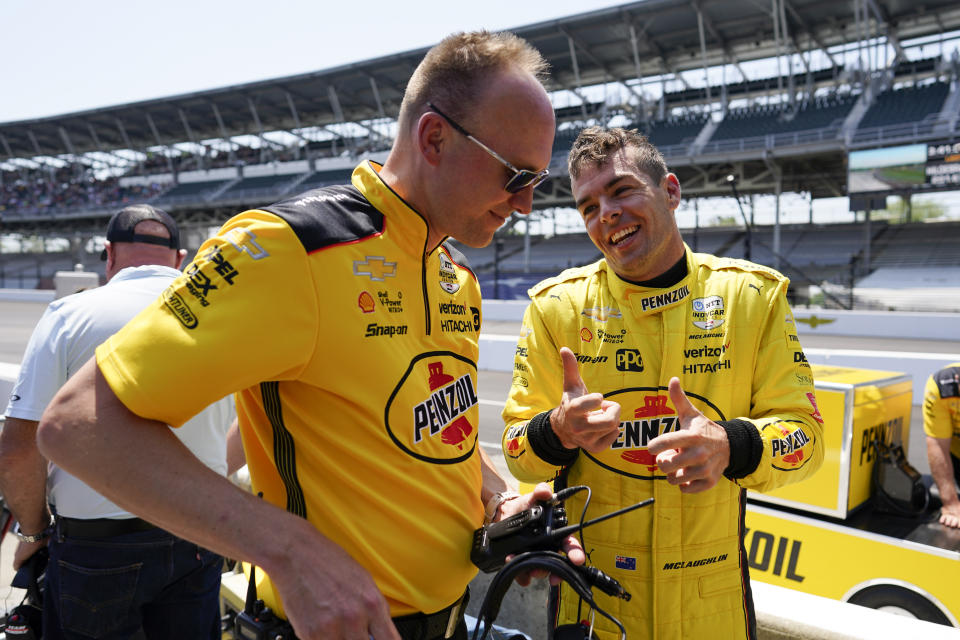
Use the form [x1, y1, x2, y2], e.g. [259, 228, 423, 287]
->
[398, 31, 549, 131]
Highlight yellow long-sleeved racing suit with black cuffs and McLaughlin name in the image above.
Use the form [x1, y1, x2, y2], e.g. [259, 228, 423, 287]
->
[502, 248, 823, 640]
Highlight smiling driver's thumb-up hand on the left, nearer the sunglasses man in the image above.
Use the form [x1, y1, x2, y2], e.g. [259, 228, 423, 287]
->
[550, 347, 620, 453]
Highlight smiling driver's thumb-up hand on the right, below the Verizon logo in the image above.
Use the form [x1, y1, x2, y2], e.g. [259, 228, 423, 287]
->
[647, 378, 730, 493]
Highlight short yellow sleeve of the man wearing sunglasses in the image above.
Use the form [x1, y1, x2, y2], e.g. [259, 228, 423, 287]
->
[97, 210, 318, 426]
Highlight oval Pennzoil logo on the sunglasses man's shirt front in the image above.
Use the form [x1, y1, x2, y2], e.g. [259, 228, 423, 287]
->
[385, 351, 480, 464]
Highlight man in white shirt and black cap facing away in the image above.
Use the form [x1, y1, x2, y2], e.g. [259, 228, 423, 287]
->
[0, 205, 239, 640]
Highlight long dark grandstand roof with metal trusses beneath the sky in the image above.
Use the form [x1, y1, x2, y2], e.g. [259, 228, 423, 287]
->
[0, 0, 960, 158]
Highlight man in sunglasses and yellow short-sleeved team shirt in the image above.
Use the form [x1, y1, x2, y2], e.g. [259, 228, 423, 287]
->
[38, 33, 583, 640]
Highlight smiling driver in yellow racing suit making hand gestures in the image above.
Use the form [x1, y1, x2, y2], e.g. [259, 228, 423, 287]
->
[503, 127, 823, 640]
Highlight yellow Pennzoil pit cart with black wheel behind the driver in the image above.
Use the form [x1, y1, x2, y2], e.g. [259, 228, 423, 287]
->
[744, 365, 960, 627]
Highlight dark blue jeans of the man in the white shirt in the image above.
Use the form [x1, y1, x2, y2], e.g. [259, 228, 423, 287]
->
[43, 529, 223, 640]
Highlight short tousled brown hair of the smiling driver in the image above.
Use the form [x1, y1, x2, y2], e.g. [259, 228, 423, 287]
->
[567, 127, 668, 184]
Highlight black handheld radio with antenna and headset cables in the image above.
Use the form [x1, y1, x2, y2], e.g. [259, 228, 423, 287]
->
[470, 485, 653, 640]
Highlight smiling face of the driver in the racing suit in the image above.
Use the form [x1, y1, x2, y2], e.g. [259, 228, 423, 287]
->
[571, 148, 684, 282]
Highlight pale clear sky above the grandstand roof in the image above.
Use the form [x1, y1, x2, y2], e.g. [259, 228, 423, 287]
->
[0, 0, 623, 122]
